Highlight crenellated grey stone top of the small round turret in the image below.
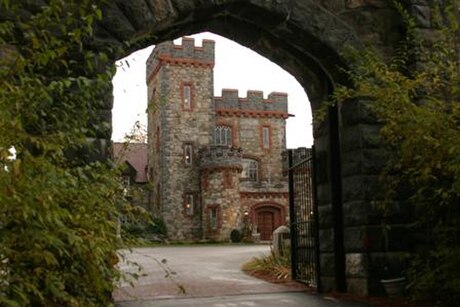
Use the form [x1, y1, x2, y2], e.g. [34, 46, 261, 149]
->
[200, 145, 243, 170]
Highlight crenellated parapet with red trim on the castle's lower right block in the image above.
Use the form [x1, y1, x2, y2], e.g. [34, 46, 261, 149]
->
[214, 89, 289, 118]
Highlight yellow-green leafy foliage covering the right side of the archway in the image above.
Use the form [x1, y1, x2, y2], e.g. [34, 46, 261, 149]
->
[332, 0, 460, 302]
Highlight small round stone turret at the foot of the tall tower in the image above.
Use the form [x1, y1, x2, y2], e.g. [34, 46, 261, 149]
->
[200, 145, 244, 241]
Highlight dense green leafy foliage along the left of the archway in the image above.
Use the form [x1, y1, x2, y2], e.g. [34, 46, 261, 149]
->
[0, 0, 126, 306]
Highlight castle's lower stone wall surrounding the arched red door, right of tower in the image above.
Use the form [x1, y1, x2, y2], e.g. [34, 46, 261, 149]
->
[215, 89, 289, 239]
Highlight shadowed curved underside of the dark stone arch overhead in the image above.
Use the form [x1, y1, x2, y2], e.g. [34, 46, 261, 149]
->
[97, 1, 362, 109]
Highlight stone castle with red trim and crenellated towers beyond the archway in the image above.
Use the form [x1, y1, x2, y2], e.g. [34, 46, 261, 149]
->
[147, 38, 289, 241]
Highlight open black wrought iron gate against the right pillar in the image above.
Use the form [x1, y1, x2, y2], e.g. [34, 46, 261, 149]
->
[287, 148, 320, 291]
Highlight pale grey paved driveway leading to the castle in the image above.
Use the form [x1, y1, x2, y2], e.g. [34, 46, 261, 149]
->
[114, 245, 368, 307]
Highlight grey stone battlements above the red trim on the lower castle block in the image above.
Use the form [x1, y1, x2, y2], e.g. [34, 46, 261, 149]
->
[214, 89, 288, 113]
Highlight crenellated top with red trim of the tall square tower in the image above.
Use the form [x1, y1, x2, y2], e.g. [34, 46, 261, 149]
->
[147, 37, 215, 77]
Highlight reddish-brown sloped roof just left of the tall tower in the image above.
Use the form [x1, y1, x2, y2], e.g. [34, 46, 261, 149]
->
[113, 143, 147, 183]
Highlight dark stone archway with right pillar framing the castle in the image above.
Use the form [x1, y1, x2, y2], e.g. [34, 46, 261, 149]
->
[6, 0, 414, 294]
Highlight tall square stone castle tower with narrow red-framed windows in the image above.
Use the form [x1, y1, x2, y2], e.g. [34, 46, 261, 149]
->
[147, 38, 215, 240]
